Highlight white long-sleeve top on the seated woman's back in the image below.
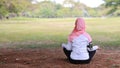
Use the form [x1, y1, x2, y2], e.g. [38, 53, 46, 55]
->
[62, 34, 89, 60]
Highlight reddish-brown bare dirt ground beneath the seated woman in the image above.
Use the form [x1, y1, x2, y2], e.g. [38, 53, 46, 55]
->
[0, 48, 120, 68]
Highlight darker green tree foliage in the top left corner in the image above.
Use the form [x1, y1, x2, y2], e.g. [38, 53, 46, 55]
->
[0, 0, 31, 17]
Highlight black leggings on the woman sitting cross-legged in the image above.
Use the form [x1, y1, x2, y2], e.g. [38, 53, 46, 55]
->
[63, 48, 96, 64]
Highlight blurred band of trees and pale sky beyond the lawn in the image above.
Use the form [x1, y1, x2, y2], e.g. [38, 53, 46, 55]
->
[0, 0, 120, 19]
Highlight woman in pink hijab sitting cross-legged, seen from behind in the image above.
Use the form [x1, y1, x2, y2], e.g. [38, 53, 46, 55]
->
[62, 18, 98, 64]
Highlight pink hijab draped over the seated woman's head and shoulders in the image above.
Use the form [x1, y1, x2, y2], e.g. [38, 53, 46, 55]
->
[68, 18, 92, 42]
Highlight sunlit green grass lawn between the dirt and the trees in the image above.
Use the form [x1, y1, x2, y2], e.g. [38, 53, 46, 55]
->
[0, 17, 120, 48]
